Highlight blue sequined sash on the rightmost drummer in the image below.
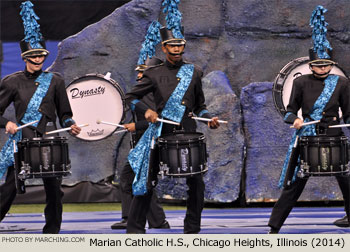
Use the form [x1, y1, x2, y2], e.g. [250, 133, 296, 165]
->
[278, 75, 339, 188]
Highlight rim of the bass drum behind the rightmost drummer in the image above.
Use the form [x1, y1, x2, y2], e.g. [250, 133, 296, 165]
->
[272, 56, 349, 118]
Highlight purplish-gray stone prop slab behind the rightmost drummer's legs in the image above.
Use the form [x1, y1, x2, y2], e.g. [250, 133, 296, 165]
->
[241, 82, 342, 202]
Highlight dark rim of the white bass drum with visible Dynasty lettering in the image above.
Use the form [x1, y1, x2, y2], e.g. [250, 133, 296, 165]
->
[66, 73, 126, 142]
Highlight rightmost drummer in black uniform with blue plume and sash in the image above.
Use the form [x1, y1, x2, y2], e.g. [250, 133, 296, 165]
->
[268, 6, 350, 233]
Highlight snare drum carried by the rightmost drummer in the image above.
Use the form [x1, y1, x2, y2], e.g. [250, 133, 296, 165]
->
[299, 136, 349, 176]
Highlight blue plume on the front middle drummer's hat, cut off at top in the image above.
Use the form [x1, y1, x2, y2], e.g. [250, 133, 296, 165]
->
[162, 0, 184, 39]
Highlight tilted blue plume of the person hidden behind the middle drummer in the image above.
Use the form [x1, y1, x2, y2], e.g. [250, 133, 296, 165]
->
[137, 21, 161, 65]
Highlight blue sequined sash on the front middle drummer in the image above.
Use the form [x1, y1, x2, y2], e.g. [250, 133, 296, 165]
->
[128, 64, 194, 195]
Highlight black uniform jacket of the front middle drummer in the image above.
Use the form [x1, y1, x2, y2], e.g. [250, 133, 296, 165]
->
[126, 57, 211, 131]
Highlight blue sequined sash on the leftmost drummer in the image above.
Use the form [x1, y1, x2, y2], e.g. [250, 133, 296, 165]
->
[0, 72, 53, 178]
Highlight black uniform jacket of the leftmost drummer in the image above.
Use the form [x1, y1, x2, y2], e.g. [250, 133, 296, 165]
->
[0, 71, 73, 134]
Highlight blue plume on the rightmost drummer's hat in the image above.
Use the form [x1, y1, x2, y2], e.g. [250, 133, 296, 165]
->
[310, 5, 333, 59]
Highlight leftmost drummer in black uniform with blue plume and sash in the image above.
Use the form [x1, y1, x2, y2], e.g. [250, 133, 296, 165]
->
[0, 1, 81, 234]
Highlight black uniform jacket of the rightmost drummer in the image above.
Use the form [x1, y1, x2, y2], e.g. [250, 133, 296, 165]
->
[285, 74, 350, 134]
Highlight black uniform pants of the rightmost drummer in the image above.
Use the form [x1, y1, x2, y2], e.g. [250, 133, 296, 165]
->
[268, 176, 350, 229]
